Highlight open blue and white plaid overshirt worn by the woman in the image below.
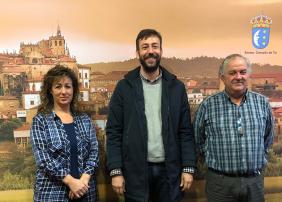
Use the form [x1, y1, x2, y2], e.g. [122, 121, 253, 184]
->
[30, 112, 99, 202]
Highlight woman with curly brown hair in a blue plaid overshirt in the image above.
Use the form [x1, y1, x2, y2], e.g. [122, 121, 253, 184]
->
[31, 65, 98, 202]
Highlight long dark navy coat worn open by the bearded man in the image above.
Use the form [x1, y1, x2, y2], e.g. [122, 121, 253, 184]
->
[106, 67, 195, 201]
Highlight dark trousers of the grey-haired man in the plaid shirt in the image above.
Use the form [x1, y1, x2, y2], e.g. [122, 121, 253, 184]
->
[206, 170, 264, 202]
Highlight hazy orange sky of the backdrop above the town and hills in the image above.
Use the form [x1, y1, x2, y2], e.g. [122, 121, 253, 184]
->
[0, 0, 282, 65]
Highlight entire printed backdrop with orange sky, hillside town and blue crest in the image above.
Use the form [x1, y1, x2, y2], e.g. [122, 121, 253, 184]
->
[0, 0, 282, 202]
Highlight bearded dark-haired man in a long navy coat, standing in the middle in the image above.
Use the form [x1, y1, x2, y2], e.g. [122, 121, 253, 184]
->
[106, 29, 196, 202]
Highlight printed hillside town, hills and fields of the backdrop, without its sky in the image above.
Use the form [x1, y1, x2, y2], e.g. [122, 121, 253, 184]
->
[0, 25, 282, 201]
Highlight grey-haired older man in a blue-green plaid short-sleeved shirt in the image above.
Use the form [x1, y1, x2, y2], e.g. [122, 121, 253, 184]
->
[194, 54, 274, 202]
